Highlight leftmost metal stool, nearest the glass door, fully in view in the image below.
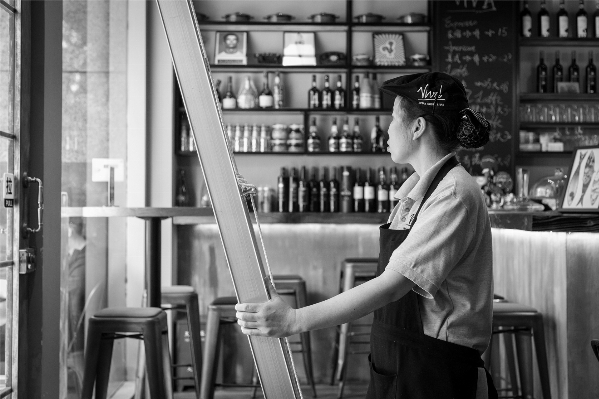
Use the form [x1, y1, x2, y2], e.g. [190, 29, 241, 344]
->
[81, 308, 173, 399]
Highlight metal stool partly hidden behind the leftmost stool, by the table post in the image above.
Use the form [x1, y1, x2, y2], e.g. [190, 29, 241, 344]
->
[161, 285, 202, 399]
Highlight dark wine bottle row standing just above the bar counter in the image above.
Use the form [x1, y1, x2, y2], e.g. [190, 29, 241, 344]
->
[264, 166, 408, 213]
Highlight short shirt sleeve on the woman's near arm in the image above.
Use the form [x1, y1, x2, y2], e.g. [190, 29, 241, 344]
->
[387, 190, 476, 299]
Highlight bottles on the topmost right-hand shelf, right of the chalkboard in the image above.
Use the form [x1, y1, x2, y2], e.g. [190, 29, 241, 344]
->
[520, 0, 599, 38]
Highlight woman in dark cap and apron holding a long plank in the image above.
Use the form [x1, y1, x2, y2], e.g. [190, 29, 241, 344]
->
[236, 72, 497, 399]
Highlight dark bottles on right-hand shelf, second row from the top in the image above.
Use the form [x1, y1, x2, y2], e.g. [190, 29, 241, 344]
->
[537, 51, 597, 94]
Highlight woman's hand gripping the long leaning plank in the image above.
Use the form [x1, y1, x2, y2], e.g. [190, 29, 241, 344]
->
[235, 286, 300, 338]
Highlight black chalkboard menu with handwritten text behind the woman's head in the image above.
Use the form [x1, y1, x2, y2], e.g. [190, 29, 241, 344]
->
[433, 0, 518, 176]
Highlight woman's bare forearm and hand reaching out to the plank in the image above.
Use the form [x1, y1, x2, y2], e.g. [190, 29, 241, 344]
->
[235, 270, 414, 338]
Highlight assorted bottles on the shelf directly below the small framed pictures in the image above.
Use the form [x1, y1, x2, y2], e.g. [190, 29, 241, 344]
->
[215, 72, 382, 110]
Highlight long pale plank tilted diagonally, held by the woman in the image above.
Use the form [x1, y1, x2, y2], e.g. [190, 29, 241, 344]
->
[156, 0, 302, 399]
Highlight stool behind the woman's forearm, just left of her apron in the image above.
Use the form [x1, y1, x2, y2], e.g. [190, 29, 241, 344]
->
[331, 258, 379, 398]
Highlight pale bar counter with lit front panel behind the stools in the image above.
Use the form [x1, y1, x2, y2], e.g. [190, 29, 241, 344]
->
[173, 211, 599, 399]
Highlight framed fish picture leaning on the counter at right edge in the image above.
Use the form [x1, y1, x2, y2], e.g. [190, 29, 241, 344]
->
[558, 146, 599, 213]
